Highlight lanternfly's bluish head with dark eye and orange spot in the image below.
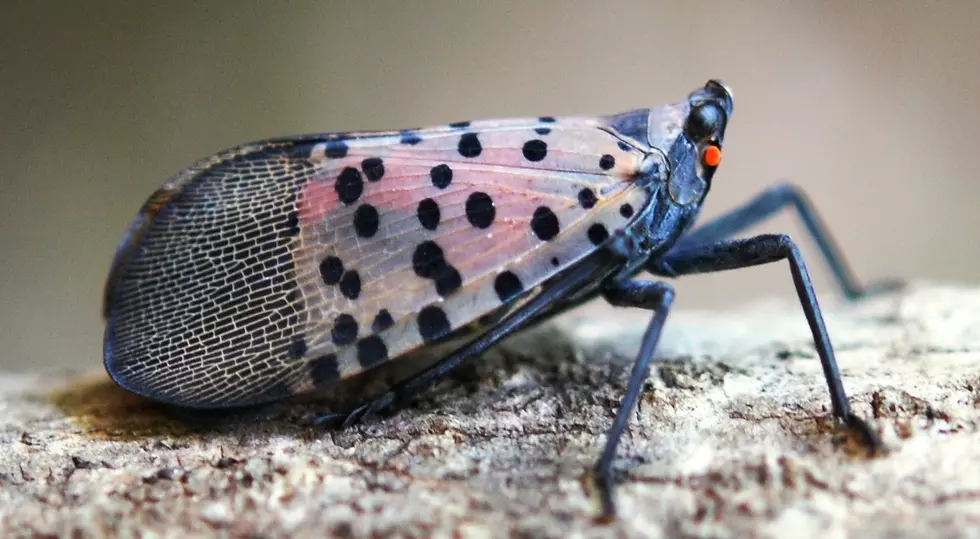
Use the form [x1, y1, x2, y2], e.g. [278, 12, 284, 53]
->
[646, 80, 733, 206]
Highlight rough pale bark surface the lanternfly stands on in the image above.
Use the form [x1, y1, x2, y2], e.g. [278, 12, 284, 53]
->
[0, 284, 980, 538]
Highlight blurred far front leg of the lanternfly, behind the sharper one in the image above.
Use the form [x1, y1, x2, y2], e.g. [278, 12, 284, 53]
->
[646, 183, 902, 300]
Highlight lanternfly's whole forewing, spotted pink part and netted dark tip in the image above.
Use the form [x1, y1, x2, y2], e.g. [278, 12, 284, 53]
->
[105, 118, 650, 407]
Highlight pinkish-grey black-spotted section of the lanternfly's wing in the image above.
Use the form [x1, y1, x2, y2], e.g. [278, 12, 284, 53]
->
[297, 118, 649, 389]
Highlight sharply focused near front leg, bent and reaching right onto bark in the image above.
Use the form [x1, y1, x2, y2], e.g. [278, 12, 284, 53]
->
[652, 234, 881, 452]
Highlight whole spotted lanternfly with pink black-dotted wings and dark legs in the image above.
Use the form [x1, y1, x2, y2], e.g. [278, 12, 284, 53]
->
[103, 80, 896, 515]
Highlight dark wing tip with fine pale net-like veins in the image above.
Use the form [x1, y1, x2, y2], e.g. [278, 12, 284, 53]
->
[105, 141, 309, 406]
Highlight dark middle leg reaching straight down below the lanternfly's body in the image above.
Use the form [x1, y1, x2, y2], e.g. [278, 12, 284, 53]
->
[594, 281, 674, 518]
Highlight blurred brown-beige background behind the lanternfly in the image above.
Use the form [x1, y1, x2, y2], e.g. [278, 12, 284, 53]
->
[0, 0, 980, 368]
